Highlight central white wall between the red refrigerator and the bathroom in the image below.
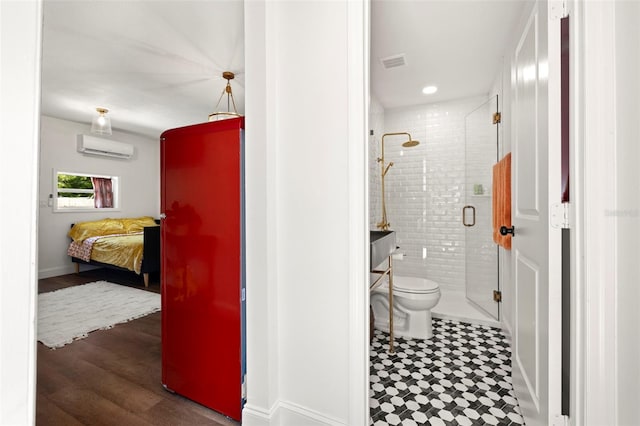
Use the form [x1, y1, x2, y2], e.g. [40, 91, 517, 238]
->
[243, 1, 368, 425]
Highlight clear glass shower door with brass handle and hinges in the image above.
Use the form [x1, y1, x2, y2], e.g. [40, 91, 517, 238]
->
[462, 96, 500, 320]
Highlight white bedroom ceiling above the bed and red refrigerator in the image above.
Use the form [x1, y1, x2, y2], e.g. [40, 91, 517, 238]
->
[42, 0, 244, 138]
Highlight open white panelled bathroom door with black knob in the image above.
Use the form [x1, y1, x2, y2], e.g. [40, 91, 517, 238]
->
[512, 1, 561, 426]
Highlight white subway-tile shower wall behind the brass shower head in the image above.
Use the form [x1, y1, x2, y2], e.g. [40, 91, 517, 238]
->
[378, 96, 488, 291]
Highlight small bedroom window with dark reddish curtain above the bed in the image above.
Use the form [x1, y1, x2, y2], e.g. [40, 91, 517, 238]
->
[52, 171, 119, 211]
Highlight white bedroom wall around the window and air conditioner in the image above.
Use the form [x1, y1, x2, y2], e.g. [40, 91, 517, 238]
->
[38, 116, 160, 278]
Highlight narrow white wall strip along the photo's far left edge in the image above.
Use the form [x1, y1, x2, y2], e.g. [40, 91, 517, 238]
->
[0, 1, 42, 425]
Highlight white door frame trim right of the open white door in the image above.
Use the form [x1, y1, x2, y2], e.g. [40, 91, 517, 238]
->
[568, 0, 619, 425]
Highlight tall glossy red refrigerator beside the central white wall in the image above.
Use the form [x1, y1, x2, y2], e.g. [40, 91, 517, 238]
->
[161, 118, 244, 420]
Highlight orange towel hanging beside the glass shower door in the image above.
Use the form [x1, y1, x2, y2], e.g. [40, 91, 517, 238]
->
[493, 153, 511, 250]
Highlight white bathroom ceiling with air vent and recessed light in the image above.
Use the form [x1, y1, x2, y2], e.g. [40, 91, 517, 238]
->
[371, 0, 526, 108]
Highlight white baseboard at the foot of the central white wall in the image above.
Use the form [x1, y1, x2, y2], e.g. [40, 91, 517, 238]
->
[242, 401, 346, 426]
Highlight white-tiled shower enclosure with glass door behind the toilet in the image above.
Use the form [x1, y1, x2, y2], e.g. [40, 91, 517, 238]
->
[369, 96, 499, 323]
